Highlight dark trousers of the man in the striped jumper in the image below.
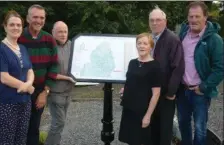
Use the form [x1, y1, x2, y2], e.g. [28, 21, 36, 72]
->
[26, 89, 44, 145]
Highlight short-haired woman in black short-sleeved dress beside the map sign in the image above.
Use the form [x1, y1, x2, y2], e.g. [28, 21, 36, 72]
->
[119, 33, 161, 145]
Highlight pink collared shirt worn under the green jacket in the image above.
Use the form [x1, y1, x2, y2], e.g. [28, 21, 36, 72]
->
[182, 26, 206, 86]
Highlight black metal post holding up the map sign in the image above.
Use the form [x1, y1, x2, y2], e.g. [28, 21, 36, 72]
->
[101, 83, 114, 145]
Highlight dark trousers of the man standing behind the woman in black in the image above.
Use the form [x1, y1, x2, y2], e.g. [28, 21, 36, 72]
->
[151, 97, 175, 145]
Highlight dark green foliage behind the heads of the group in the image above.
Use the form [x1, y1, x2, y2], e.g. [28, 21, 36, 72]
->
[0, 1, 220, 39]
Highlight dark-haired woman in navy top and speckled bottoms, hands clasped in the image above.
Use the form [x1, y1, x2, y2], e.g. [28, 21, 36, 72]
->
[0, 11, 34, 145]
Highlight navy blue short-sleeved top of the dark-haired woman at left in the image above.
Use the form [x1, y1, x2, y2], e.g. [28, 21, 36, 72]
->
[0, 42, 32, 104]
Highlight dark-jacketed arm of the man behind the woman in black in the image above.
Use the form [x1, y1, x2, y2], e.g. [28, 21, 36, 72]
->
[166, 39, 184, 97]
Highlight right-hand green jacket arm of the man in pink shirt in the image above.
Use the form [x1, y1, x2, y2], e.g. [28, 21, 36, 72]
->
[199, 34, 224, 93]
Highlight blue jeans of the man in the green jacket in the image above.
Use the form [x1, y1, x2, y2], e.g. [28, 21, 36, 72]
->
[177, 87, 211, 145]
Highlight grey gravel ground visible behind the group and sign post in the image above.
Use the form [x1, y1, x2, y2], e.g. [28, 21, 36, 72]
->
[41, 93, 224, 145]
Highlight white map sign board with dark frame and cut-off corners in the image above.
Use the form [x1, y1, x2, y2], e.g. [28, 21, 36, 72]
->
[70, 35, 137, 82]
